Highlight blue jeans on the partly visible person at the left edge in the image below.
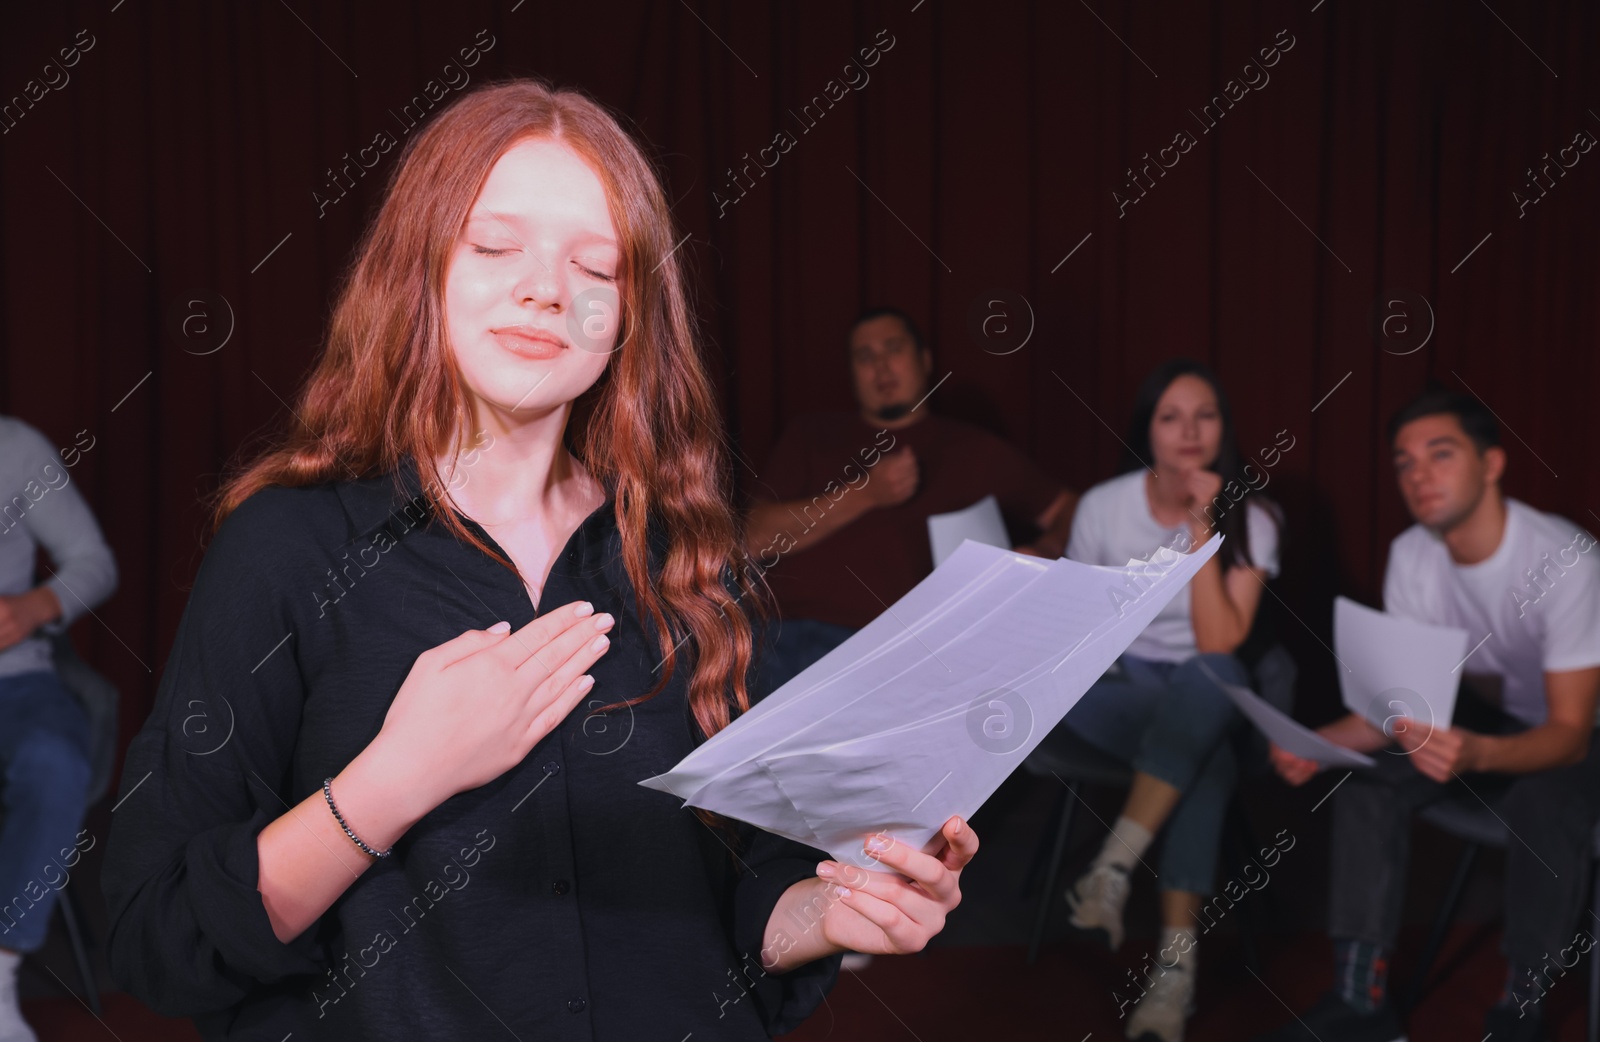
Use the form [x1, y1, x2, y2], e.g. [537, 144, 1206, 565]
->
[0, 669, 90, 952]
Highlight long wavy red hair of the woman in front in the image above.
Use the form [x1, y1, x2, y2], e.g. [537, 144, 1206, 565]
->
[213, 78, 766, 774]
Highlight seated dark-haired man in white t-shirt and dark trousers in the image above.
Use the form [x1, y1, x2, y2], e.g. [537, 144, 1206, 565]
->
[1264, 391, 1600, 1042]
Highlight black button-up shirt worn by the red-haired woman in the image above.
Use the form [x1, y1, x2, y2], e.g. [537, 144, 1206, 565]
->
[102, 459, 840, 1042]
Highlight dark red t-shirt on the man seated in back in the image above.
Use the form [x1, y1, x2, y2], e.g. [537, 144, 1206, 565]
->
[750, 413, 1062, 627]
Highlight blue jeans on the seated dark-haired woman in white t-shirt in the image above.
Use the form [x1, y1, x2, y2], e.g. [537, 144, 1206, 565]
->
[1061, 655, 1250, 896]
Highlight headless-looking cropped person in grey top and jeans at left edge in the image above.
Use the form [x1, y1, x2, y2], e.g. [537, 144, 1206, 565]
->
[0, 416, 117, 1042]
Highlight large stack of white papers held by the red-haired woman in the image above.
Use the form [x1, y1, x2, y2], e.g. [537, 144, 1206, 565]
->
[640, 536, 1221, 866]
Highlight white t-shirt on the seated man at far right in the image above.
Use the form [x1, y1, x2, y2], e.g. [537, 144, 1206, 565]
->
[1384, 498, 1600, 727]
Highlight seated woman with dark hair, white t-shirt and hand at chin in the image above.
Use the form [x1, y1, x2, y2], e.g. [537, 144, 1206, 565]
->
[1046, 359, 1278, 1042]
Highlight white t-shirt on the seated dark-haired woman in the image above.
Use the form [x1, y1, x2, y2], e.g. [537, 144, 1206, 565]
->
[1066, 467, 1278, 663]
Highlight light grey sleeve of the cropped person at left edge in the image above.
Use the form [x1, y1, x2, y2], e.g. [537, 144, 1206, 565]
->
[6, 423, 117, 634]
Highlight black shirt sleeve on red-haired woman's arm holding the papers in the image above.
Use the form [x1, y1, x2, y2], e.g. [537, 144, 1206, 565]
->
[733, 823, 845, 1037]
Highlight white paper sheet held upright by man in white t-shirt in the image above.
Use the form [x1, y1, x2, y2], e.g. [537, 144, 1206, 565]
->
[1333, 597, 1467, 735]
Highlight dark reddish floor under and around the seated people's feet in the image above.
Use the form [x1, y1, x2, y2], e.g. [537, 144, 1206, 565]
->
[22, 761, 1600, 1042]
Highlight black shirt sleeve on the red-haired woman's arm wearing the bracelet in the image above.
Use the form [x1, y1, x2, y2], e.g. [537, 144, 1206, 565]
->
[101, 488, 325, 1016]
